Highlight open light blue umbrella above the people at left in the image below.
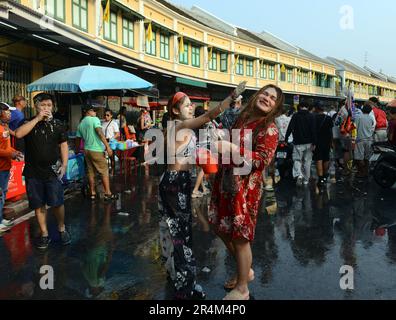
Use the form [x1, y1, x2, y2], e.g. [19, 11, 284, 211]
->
[27, 65, 153, 92]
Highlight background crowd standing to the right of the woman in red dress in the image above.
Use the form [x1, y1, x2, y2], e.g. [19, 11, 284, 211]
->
[281, 97, 395, 188]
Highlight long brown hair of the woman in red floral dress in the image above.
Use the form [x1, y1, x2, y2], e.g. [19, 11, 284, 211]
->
[233, 84, 285, 141]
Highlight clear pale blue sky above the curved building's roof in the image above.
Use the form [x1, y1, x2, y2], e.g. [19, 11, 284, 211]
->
[168, 0, 396, 77]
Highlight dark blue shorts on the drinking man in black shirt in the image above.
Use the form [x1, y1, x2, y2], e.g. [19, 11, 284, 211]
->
[26, 178, 64, 210]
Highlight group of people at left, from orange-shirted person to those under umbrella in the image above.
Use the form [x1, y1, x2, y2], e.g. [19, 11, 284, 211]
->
[0, 93, 152, 241]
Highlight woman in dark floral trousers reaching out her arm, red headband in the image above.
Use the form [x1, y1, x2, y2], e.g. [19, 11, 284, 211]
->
[158, 85, 244, 299]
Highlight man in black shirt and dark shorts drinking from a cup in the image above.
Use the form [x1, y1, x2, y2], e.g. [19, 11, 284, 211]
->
[15, 93, 71, 249]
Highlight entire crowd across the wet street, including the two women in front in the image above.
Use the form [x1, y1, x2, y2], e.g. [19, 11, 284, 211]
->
[0, 85, 396, 300]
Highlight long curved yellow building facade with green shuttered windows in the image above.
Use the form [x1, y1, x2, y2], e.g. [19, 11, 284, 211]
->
[0, 0, 396, 102]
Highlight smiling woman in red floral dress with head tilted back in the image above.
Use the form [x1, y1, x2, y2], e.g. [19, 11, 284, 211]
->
[209, 85, 284, 300]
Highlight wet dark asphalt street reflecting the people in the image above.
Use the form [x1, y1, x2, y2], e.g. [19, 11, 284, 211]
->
[0, 168, 396, 300]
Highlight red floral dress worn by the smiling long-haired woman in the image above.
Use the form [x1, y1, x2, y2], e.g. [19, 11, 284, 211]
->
[208, 120, 278, 241]
